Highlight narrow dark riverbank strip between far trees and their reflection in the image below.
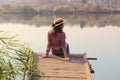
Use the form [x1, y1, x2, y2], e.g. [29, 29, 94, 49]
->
[0, 10, 120, 15]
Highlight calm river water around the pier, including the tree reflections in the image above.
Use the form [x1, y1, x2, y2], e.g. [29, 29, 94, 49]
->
[0, 14, 120, 80]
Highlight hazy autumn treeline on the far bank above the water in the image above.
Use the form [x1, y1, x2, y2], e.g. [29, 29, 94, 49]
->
[2, 0, 120, 14]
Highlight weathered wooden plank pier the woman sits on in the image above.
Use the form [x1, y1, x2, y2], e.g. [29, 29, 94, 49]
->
[32, 53, 92, 80]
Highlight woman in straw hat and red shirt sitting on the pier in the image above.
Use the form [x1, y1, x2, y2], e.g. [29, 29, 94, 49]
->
[43, 18, 70, 61]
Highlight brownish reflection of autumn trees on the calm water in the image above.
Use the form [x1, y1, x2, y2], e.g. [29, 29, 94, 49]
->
[0, 14, 120, 28]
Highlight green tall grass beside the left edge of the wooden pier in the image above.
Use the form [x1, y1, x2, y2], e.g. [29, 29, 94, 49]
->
[0, 32, 34, 80]
